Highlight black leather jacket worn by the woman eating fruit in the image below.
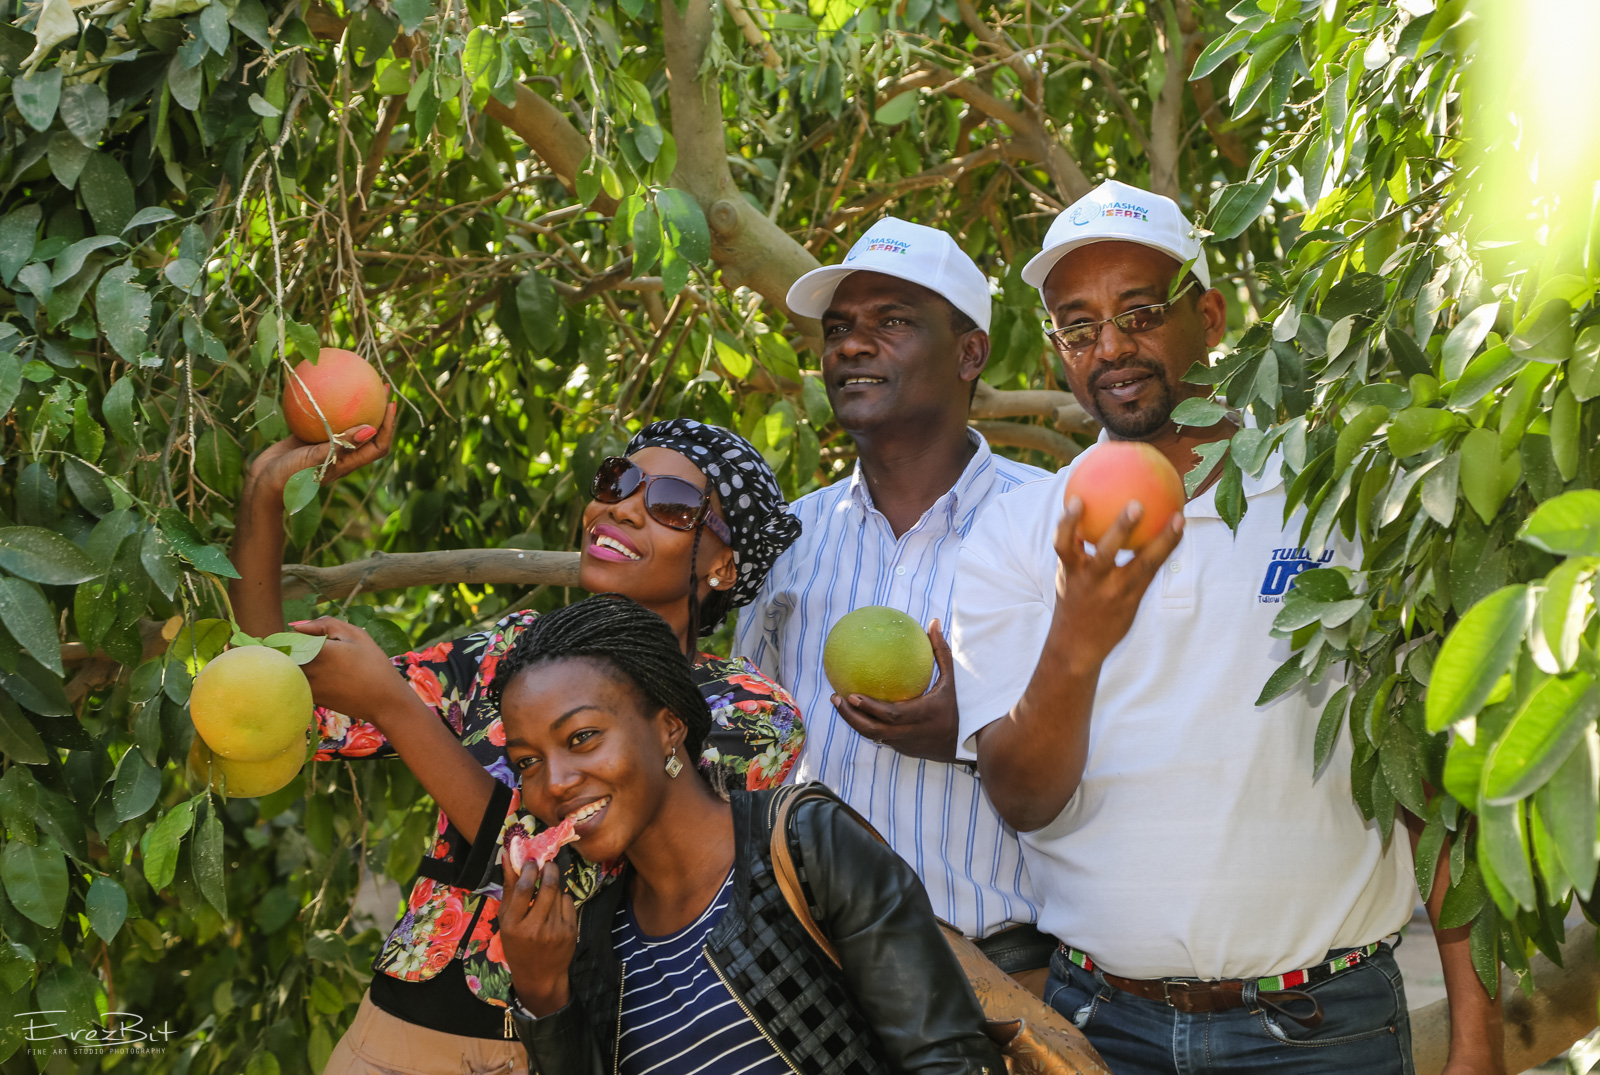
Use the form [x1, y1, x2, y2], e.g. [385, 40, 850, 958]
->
[514, 780, 1006, 1075]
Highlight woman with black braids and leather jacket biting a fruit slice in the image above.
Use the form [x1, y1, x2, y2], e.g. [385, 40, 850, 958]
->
[491, 597, 1005, 1075]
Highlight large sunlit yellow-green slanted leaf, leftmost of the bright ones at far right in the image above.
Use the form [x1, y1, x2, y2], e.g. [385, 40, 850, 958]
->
[1427, 584, 1531, 731]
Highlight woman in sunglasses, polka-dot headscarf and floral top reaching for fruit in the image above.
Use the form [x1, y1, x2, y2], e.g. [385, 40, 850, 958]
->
[230, 408, 803, 1075]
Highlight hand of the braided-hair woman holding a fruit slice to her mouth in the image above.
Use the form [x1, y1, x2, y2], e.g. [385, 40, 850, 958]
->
[499, 848, 578, 1016]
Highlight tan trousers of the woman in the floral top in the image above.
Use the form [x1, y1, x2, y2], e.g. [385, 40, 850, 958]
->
[322, 995, 528, 1075]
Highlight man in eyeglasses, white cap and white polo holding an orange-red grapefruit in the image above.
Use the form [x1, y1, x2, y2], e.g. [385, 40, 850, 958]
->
[952, 181, 1502, 1075]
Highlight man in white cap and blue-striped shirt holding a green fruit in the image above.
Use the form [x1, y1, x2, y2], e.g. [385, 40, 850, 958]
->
[734, 218, 1053, 977]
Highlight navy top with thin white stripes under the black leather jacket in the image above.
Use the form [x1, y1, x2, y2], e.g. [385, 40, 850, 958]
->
[611, 872, 790, 1075]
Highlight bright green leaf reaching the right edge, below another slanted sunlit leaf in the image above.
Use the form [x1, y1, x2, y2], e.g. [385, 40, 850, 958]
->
[1483, 672, 1600, 806]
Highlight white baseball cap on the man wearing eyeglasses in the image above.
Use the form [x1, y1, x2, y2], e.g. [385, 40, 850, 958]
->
[1022, 179, 1211, 288]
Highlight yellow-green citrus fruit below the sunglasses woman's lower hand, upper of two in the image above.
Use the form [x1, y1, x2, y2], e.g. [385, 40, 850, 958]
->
[189, 646, 312, 761]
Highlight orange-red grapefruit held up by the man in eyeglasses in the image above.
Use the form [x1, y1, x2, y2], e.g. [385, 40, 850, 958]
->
[1062, 440, 1186, 549]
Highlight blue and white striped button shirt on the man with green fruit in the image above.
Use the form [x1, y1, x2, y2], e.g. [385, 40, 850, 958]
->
[734, 430, 1050, 937]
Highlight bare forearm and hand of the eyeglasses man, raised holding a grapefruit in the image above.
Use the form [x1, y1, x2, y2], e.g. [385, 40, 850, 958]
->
[978, 498, 1184, 832]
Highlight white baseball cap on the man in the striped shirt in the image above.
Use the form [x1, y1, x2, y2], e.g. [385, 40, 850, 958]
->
[789, 216, 989, 333]
